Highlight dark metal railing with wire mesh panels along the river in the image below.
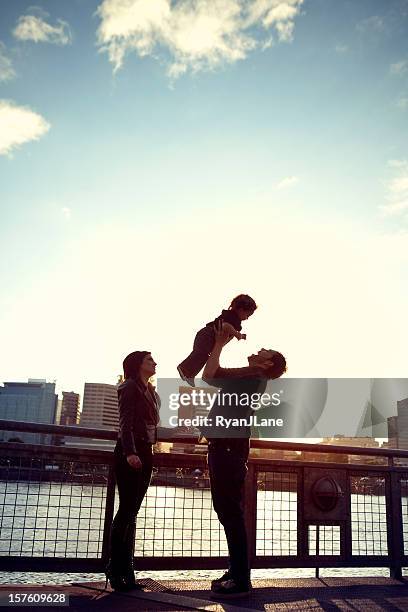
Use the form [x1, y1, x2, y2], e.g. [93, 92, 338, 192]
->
[0, 421, 408, 578]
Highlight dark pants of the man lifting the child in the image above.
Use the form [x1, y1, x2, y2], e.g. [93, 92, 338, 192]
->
[208, 438, 250, 585]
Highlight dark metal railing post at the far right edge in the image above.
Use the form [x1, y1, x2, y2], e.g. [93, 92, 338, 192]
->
[386, 457, 404, 580]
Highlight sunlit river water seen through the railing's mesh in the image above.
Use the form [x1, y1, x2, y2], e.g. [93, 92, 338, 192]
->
[0, 482, 407, 584]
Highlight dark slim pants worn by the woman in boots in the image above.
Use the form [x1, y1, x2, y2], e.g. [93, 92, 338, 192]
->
[110, 443, 153, 576]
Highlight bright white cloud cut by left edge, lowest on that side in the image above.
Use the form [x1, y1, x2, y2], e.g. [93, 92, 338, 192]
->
[0, 100, 51, 155]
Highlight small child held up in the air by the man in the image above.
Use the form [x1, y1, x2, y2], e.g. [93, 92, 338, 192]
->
[177, 294, 257, 386]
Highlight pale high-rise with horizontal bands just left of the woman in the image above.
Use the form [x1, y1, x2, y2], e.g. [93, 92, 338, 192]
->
[80, 383, 119, 430]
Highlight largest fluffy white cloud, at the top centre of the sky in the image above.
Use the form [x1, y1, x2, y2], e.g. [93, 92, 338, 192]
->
[97, 0, 304, 78]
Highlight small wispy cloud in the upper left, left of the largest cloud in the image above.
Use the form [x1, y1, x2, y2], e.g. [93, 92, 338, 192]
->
[13, 14, 72, 45]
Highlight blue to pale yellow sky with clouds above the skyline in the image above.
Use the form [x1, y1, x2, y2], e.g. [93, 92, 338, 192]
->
[0, 0, 408, 394]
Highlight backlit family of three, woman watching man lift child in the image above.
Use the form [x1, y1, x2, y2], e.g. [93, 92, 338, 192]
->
[106, 294, 286, 599]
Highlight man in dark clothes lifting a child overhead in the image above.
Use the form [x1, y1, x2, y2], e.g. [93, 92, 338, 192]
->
[202, 325, 286, 598]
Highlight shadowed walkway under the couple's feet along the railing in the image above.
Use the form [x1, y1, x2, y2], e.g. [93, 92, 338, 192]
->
[0, 578, 408, 612]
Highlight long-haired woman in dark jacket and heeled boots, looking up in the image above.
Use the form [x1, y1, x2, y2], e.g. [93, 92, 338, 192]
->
[106, 351, 160, 591]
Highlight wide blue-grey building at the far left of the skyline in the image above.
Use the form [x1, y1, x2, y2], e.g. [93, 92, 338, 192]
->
[0, 378, 58, 444]
